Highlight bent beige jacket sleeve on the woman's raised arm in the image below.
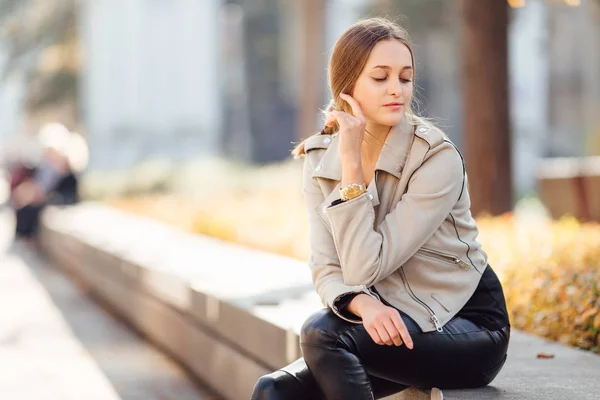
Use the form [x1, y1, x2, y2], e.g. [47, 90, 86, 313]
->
[327, 146, 464, 286]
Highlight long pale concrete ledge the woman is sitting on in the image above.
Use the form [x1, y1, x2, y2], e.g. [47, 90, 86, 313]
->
[40, 204, 600, 400]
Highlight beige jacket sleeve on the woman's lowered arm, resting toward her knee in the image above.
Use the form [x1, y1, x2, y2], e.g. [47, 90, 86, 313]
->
[302, 156, 379, 323]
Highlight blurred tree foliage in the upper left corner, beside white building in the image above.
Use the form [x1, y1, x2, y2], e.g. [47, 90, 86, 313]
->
[0, 0, 80, 120]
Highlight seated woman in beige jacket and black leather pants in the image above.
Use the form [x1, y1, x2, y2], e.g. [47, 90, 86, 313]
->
[252, 19, 510, 400]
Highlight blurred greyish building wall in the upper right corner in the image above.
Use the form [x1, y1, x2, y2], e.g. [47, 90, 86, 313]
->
[546, 0, 600, 156]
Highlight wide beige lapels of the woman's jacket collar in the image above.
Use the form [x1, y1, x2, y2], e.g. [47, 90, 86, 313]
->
[312, 115, 415, 181]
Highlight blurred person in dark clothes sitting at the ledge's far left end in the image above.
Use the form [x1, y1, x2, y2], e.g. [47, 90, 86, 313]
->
[10, 124, 84, 238]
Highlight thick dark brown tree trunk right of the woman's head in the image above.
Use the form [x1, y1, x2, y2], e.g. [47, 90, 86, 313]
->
[461, 0, 513, 215]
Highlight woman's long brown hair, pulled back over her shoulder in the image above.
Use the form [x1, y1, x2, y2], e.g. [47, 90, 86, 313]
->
[292, 18, 415, 158]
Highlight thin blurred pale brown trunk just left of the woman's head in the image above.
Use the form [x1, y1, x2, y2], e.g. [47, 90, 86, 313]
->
[297, 0, 325, 140]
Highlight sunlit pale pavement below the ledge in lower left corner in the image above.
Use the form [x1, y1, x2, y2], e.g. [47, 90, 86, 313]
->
[0, 207, 217, 400]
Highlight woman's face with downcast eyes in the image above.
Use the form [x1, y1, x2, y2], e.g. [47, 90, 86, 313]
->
[352, 40, 414, 126]
